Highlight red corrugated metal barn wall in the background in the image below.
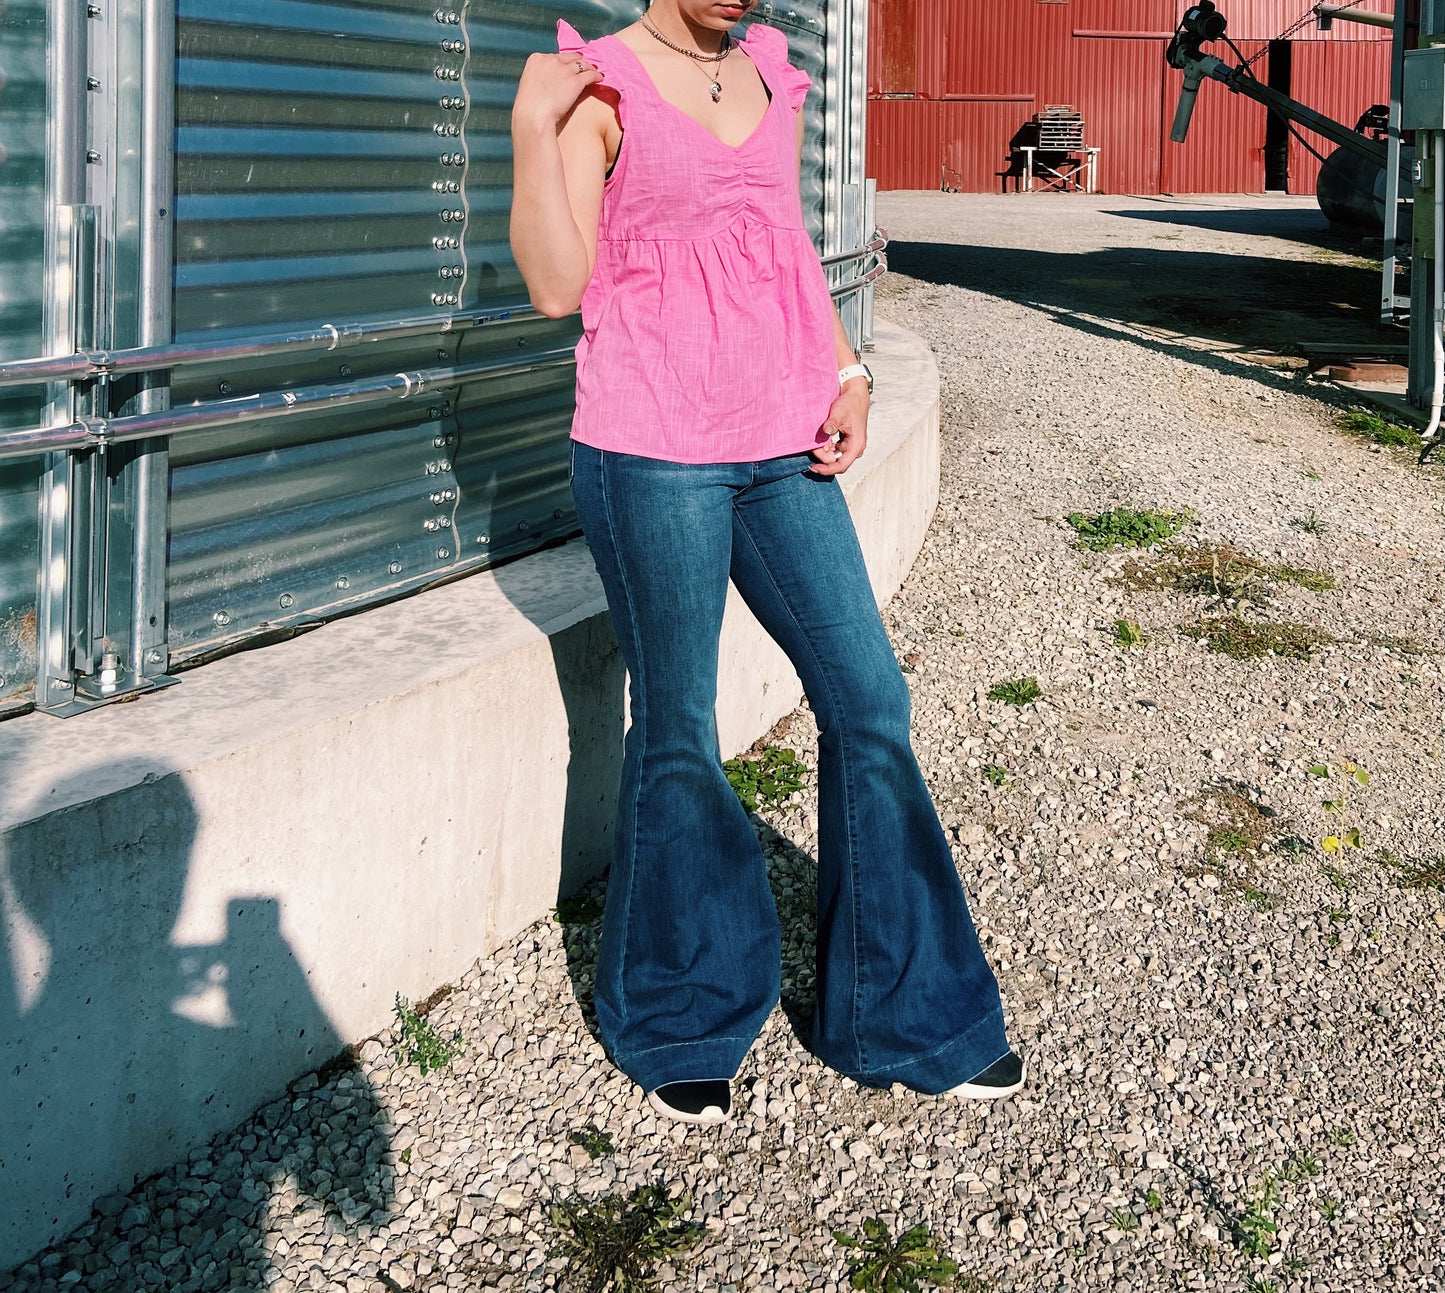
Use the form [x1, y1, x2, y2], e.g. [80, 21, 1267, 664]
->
[868, 0, 1390, 194]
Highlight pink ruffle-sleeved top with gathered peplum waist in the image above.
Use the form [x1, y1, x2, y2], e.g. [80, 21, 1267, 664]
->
[556, 22, 838, 462]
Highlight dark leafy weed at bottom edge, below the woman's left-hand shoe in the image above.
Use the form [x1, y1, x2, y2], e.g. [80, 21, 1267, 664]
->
[551, 1182, 704, 1293]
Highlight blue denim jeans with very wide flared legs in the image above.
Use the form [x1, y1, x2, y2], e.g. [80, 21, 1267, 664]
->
[572, 442, 1009, 1094]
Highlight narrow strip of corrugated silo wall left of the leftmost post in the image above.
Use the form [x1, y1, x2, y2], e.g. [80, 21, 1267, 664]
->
[0, 0, 46, 715]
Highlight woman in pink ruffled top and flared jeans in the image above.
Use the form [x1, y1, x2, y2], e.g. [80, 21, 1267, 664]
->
[512, 0, 1023, 1124]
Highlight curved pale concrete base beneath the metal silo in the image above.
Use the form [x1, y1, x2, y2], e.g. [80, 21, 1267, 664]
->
[0, 324, 939, 1270]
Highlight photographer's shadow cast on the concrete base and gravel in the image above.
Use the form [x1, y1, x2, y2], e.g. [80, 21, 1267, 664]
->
[0, 770, 393, 1293]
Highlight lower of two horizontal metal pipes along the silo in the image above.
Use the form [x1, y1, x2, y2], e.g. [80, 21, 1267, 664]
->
[0, 345, 574, 461]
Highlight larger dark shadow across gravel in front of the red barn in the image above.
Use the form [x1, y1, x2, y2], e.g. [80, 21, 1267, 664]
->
[889, 238, 1406, 389]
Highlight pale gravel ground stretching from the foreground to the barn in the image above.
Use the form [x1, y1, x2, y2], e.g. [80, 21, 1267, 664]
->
[0, 194, 1445, 1293]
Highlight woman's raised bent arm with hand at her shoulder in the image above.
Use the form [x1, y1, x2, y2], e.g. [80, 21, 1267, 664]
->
[512, 53, 613, 319]
